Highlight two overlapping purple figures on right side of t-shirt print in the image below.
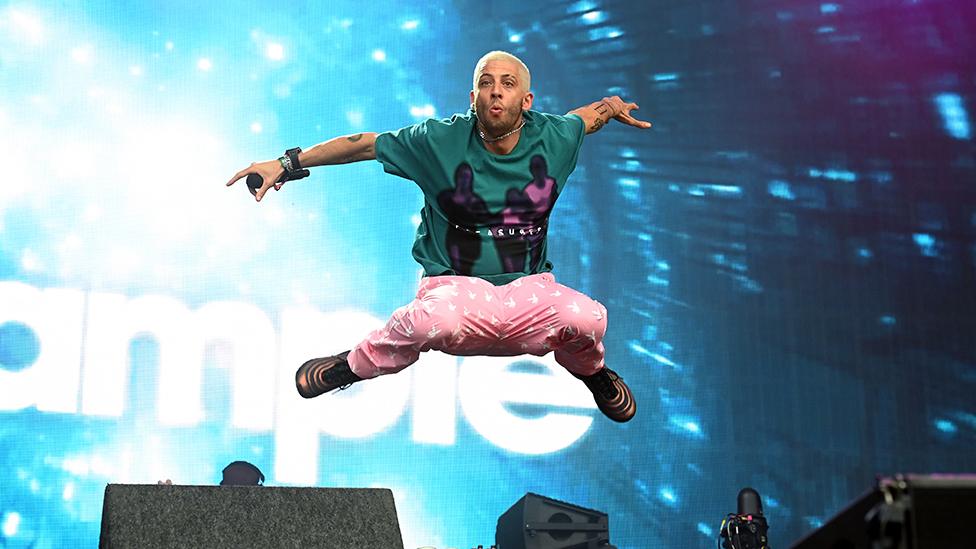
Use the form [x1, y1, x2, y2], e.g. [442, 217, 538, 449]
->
[491, 155, 559, 273]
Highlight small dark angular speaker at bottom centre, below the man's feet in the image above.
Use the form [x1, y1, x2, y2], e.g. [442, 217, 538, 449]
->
[495, 493, 610, 549]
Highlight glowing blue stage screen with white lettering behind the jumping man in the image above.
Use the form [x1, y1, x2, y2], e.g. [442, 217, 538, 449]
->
[0, 0, 976, 549]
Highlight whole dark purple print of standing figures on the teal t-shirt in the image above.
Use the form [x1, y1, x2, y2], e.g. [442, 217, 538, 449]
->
[437, 155, 559, 275]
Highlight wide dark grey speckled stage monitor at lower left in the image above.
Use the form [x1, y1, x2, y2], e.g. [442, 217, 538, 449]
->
[98, 484, 403, 549]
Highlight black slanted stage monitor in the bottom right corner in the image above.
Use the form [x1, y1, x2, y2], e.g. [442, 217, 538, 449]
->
[792, 475, 976, 549]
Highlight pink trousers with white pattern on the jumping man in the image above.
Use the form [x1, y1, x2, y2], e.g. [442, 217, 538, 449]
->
[348, 273, 607, 379]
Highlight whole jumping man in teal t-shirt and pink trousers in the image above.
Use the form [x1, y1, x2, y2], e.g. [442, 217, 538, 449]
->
[227, 51, 651, 422]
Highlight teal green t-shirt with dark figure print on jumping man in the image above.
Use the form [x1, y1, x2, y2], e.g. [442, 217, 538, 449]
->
[376, 111, 586, 285]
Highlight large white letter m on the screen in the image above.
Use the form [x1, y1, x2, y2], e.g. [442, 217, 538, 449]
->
[82, 293, 276, 430]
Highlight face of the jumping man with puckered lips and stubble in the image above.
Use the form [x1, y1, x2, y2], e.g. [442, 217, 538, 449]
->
[471, 61, 532, 136]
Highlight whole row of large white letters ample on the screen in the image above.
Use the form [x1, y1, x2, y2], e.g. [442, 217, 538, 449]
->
[0, 282, 595, 484]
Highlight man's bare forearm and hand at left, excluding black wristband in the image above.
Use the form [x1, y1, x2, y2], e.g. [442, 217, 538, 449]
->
[227, 132, 377, 202]
